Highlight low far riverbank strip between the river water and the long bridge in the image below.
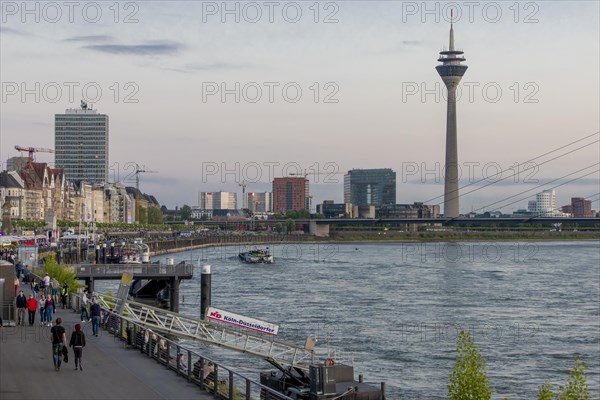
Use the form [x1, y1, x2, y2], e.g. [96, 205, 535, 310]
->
[148, 231, 600, 257]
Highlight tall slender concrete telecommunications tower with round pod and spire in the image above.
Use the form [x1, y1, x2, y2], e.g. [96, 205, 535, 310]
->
[435, 13, 468, 218]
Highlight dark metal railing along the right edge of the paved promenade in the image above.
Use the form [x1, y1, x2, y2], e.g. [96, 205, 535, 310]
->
[70, 293, 293, 400]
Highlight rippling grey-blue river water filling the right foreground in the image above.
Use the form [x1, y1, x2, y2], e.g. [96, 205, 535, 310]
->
[96, 241, 600, 399]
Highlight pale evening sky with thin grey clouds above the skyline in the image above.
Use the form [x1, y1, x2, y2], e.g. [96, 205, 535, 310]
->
[0, 1, 600, 213]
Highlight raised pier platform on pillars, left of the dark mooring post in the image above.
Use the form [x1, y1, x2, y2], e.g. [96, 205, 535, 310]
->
[72, 261, 194, 312]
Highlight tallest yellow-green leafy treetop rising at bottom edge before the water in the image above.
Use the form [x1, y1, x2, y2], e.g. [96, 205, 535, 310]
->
[448, 331, 492, 400]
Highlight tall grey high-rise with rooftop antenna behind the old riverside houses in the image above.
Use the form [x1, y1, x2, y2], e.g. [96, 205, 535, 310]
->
[54, 101, 108, 183]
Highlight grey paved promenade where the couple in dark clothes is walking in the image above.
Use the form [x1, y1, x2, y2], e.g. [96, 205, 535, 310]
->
[0, 287, 212, 400]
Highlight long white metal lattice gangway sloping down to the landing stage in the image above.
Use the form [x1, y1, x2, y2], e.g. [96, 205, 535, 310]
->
[93, 292, 316, 374]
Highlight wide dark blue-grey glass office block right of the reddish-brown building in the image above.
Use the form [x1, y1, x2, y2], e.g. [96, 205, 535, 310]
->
[344, 168, 396, 207]
